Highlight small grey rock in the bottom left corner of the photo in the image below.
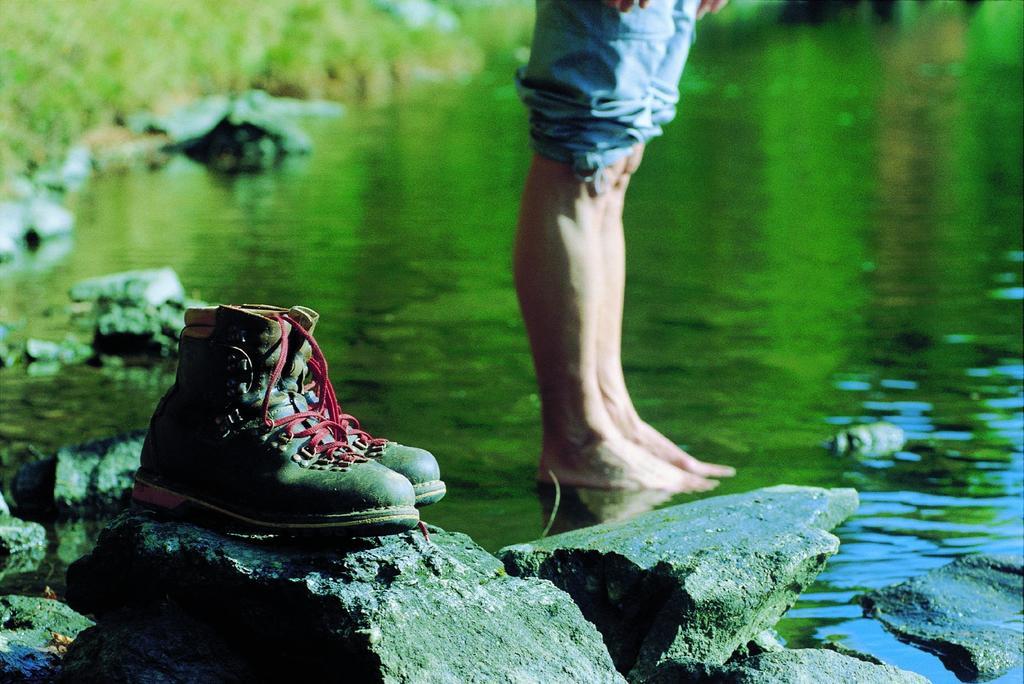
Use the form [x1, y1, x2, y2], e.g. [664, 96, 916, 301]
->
[0, 595, 93, 682]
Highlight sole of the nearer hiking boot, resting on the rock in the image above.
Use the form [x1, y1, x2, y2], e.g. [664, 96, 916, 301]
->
[132, 474, 420, 537]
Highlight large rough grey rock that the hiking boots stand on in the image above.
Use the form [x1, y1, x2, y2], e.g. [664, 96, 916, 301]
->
[68, 511, 622, 682]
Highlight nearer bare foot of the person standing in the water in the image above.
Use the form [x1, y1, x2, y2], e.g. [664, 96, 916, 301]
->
[538, 434, 718, 494]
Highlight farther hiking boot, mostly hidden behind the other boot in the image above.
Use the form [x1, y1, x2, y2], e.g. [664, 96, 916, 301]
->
[290, 306, 446, 506]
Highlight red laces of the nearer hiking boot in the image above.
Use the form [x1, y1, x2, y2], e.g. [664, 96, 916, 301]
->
[263, 314, 387, 463]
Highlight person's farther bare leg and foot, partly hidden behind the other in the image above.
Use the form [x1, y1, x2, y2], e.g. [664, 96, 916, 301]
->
[597, 145, 735, 475]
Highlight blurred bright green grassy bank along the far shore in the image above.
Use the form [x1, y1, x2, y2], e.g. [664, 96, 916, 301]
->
[0, 0, 532, 180]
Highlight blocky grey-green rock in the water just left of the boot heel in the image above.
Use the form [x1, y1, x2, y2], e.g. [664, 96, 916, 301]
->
[53, 430, 146, 518]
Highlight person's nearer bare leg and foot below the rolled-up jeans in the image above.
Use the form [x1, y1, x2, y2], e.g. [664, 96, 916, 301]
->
[515, 156, 713, 491]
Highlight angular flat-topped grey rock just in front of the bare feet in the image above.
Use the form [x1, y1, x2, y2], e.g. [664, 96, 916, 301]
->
[501, 485, 857, 681]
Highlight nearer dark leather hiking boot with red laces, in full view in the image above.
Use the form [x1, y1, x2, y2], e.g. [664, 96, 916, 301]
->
[132, 306, 419, 536]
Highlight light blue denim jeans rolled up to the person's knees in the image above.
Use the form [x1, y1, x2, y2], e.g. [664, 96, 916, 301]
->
[516, 0, 697, 181]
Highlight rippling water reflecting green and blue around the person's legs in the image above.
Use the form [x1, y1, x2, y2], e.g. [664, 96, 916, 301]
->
[0, 3, 1024, 682]
